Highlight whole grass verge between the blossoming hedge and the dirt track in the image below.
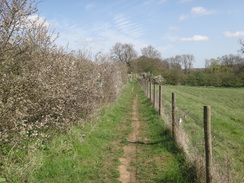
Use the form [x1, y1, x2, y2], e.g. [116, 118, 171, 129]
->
[0, 85, 134, 183]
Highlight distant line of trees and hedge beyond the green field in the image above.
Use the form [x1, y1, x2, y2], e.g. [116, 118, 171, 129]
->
[131, 54, 244, 87]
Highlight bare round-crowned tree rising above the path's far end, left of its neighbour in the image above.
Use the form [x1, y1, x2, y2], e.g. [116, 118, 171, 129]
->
[111, 42, 137, 71]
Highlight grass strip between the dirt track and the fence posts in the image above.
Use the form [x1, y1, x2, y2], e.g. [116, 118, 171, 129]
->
[136, 83, 198, 183]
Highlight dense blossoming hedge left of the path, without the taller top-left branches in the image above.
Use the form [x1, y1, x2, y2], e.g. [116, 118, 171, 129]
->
[0, 51, 126, 147]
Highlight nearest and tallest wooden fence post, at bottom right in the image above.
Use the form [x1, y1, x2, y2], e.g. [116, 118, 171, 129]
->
[204, 106, 213, 183]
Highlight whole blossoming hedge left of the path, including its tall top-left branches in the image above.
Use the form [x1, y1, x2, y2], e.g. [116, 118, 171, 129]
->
[0, 0, 127, 158]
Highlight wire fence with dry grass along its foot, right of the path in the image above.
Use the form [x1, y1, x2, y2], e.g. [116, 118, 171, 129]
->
[138, 79, 244, 183]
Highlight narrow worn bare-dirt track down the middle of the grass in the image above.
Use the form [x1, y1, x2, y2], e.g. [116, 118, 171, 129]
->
[118, 93, 140, 183]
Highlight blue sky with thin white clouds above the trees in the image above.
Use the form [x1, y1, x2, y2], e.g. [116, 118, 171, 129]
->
[38, 0, 244, 68]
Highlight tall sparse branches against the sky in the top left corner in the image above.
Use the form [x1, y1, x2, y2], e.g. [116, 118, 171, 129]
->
[0, 0, 37, 63]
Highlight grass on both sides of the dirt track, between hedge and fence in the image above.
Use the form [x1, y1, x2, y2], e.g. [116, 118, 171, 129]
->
[0, 82, 197, 183]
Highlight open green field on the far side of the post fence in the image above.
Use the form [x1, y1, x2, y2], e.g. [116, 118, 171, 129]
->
[159, 85, 244, 181]
